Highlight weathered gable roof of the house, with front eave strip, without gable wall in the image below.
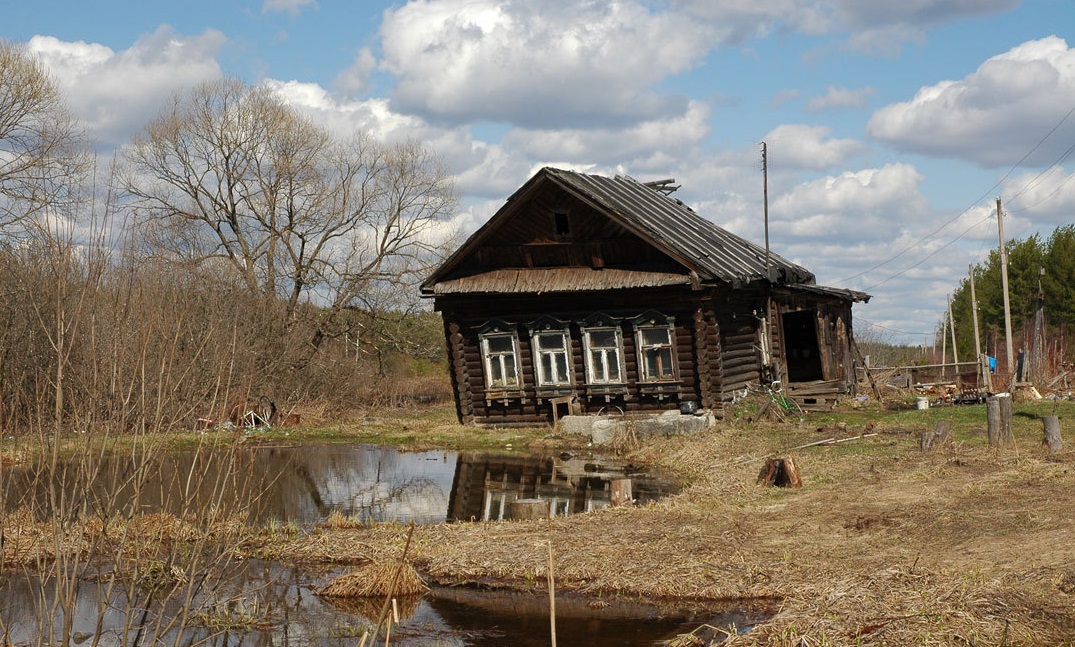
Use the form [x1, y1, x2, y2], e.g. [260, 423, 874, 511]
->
[421, 168, 864, 294]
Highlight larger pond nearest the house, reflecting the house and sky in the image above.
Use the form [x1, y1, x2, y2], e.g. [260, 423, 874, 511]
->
[3, 444, 678, 528]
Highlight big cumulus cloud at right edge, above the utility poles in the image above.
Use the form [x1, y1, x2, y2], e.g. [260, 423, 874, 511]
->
[868, 37, 1075, 167]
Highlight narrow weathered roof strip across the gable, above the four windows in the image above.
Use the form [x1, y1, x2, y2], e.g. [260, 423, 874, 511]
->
[433, 268, 690, 294]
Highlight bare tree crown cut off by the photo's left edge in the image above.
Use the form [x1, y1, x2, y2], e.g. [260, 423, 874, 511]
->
[0, 41, 88, 233]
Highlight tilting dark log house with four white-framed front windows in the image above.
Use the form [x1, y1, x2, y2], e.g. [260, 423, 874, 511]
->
[421, 168, 870, 427]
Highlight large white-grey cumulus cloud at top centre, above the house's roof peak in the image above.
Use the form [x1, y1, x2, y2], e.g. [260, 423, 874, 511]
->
[381, 0, 714, 128]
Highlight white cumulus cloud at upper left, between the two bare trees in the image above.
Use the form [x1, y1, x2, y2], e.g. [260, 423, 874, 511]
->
[28, 26, 226, 146]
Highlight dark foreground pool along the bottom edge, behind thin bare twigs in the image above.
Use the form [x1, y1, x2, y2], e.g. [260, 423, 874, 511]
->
[0, 560, 771, 647]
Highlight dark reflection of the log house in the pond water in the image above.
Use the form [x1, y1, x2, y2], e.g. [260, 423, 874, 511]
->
[447, 454, 677, 521]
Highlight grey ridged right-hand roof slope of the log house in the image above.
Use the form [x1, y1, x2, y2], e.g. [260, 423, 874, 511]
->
[542, 168, 814, 286]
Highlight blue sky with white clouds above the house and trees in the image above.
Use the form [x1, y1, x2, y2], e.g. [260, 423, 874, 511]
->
[6, 0, 1075, 344]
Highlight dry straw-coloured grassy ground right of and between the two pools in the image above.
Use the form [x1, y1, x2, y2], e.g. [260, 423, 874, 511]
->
[273, 407, 1075, 647]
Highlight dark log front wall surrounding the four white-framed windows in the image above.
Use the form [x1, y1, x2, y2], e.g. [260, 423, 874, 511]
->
[436, 289, 722, 427]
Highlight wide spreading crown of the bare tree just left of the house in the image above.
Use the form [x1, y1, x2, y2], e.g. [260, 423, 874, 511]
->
[126, 80, 456, 363]
